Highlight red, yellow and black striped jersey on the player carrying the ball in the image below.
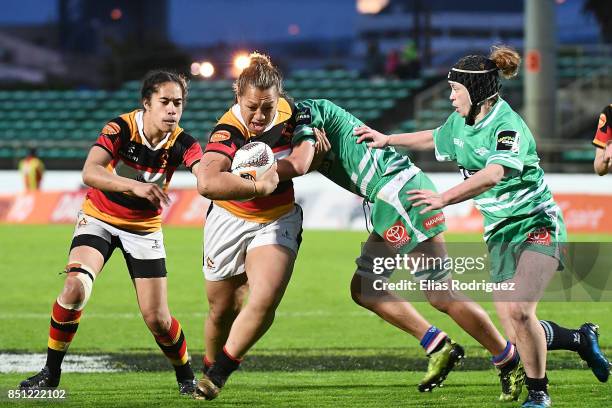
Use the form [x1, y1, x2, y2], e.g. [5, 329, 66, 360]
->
[204, 98, 295, 223]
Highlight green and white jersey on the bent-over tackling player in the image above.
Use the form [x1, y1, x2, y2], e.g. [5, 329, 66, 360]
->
[293, 99, 420, 202]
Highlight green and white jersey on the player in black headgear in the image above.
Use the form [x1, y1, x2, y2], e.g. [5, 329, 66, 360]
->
[433, 99, 556, 240]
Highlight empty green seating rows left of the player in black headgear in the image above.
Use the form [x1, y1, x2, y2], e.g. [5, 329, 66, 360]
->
[0, 70, 423, 167]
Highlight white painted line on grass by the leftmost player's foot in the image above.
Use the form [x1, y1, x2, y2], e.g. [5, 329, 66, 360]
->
[0, 353, 121, 373]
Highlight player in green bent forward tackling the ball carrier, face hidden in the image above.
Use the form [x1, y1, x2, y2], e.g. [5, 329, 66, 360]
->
[278, 99, 524, 400]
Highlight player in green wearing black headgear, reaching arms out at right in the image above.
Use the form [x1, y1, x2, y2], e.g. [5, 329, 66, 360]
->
[355, 47, 610, 407]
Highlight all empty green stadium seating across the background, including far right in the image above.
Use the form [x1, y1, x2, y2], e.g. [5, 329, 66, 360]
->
[0, 51, 612, 168]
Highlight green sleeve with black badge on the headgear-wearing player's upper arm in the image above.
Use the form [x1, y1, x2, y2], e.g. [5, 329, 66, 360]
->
[485, 124, 529, 174]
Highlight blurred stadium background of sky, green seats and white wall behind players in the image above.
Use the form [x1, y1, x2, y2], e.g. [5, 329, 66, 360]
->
[0, 0, 612, 230]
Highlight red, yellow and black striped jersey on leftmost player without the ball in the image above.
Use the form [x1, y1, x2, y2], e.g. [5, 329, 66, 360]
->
[83, 110, 202, 233]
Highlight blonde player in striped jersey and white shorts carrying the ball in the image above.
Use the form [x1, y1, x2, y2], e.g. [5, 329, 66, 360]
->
[196, 53, 330, 399]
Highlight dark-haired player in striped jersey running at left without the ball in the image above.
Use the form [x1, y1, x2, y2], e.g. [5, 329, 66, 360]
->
[20, 71, 202, 395]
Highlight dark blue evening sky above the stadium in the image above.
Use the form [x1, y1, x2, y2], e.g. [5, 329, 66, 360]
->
[0, 0, 598, 46]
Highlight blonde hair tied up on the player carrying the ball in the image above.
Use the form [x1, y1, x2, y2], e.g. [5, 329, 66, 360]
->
[233, 52, 283, 96]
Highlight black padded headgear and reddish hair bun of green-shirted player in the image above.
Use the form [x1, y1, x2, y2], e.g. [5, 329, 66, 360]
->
[448, 46, 521, 125]
